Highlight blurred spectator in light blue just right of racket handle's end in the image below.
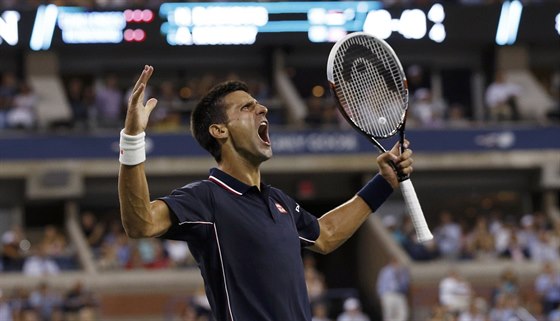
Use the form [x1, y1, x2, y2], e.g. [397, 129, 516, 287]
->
[434, 210, 463, 260]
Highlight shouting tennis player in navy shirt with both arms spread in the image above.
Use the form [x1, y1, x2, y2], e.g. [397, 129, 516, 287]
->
[119, 66, 412, 321]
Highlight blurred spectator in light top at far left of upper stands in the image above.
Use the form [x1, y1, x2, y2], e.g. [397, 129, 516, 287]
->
[6, 82, 37, 129]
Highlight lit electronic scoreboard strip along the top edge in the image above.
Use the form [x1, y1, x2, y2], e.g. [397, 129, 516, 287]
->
[0, 0, 560, 51]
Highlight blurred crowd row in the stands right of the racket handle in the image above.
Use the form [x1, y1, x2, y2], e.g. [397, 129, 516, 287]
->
[383, 210, 560, 262]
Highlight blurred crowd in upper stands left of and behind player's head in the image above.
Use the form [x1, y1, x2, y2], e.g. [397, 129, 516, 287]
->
[0, 72, 274, 131]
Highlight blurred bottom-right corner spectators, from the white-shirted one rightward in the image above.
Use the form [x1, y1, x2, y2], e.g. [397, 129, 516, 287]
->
[428, 262, 560, 321]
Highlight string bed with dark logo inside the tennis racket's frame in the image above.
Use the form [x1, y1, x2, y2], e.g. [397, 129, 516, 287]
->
[334, 37, 407, 137]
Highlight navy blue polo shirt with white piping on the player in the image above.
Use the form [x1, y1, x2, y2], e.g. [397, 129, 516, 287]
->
[161, 168, 319, 321]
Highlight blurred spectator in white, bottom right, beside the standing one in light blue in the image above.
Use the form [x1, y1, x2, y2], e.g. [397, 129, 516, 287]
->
[439, 268, 473, 315]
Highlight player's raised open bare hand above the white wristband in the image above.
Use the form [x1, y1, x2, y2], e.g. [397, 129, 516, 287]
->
[124, 65, 157, 135]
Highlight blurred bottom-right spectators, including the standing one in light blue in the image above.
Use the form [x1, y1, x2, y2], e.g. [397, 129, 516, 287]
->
[377, 250, 560, 321]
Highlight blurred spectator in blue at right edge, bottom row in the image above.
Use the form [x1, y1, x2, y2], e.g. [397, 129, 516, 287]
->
[535, 262, 560, 315]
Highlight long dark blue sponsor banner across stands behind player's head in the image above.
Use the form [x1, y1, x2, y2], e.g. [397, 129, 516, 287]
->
[0, 127, 560, 160]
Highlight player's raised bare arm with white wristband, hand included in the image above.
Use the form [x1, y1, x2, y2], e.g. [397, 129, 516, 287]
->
[118, 66, 171, 238]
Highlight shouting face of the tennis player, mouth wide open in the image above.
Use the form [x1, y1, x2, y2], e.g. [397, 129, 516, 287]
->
[224, 90, 272, 165]
